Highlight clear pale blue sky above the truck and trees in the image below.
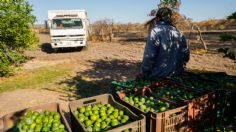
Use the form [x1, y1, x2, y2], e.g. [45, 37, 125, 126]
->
[28, 0, 236, 24]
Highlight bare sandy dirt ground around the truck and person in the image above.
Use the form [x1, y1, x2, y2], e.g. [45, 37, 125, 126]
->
[0, 34, 236, 117]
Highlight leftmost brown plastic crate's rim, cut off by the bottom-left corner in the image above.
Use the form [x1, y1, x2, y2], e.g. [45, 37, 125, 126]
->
[0, 103, 71, 132]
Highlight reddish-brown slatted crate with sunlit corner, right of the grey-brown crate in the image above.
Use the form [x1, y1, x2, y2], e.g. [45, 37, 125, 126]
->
[116, 89, 187, 132]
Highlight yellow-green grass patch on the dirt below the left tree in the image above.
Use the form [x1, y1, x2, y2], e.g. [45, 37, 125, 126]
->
[0, 65, 72, 93]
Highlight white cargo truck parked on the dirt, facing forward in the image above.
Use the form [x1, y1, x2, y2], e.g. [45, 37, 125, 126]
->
[48, 10, 89, 51]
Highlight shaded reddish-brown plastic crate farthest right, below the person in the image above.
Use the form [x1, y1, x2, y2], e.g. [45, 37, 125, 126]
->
[147, 81, 215, 131]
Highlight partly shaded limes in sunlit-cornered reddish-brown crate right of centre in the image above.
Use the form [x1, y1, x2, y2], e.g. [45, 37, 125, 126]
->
[123, 94, 175, 112]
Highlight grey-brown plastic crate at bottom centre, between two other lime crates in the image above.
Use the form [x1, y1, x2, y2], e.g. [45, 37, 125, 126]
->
[69, 94, 146, 132]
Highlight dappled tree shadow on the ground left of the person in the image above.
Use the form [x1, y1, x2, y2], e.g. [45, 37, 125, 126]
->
[56, 60, 140, 100]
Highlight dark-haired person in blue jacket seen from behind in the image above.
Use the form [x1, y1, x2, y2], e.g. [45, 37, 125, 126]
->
[137, 7, 190, 79]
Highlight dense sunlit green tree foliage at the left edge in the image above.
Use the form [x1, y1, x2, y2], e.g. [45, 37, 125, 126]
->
[0, 0, 38, 76]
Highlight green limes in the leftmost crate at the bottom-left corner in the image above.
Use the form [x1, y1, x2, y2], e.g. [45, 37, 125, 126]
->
[13, 110, 67, 132]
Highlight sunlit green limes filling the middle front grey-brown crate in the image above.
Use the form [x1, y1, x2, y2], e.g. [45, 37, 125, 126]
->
[73, 104, 130, 131]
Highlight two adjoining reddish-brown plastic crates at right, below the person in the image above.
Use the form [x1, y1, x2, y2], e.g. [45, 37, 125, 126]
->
[113, 78, 216, 132]
